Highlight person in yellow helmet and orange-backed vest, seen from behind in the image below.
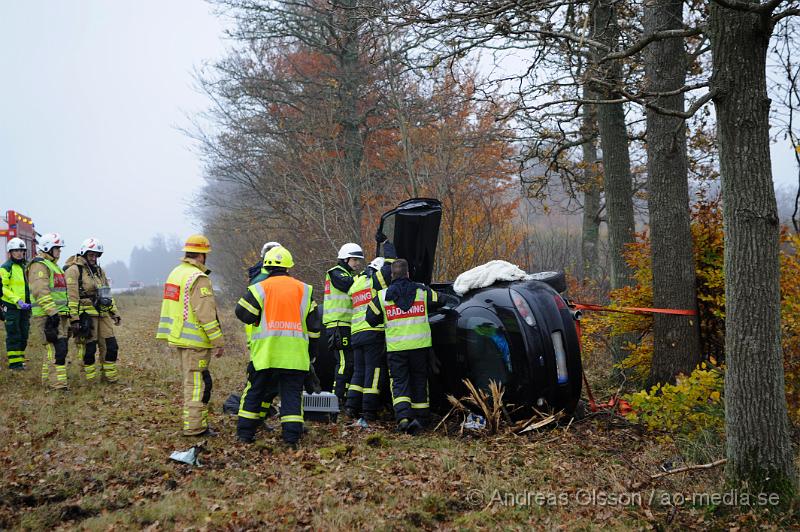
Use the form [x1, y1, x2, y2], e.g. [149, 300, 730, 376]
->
[236, 246, 321, 447]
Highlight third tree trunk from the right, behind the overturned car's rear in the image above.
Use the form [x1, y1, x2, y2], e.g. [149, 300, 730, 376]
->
[589, 0, 635, 374]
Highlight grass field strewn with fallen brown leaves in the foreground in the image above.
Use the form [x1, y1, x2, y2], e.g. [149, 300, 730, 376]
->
[0, 294, 800, 530]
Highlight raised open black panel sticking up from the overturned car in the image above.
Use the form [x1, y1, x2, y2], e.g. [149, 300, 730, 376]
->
[376, 198, 442, 284]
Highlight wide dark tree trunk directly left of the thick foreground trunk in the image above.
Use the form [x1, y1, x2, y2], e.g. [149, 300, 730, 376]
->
[644, 0, 700, 386]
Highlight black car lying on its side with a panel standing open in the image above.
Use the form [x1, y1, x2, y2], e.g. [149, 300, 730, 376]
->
[316, 198, 582, 412]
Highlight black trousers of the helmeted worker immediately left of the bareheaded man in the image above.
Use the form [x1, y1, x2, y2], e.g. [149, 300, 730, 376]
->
[347, 342, 389, 421]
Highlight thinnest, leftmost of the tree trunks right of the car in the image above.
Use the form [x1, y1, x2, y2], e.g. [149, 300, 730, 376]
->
[581, 89, 603, 279]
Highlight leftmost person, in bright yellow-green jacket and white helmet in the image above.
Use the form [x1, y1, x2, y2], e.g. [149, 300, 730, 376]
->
[0, 238, 31, 370]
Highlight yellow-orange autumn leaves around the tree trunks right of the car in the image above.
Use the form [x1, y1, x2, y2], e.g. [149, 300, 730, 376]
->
[583, 194, 800, 426]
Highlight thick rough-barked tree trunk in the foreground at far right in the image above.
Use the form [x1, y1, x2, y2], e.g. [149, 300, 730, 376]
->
[709, 2, 797, 502]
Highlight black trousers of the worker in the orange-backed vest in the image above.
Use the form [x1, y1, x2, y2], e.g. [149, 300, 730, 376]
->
[236, 362, 308, 443]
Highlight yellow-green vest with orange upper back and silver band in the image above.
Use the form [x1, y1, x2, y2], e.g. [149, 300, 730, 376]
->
[248, 275, 314, 371]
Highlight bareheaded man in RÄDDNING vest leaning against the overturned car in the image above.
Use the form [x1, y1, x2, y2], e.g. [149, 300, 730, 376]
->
[367, 259, 453, 434]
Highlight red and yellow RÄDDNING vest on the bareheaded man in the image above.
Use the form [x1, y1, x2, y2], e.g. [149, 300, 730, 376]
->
[378, 288, 433, 352]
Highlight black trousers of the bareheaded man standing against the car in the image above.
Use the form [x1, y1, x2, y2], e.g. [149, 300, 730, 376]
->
[386, 347, 430, 425]
